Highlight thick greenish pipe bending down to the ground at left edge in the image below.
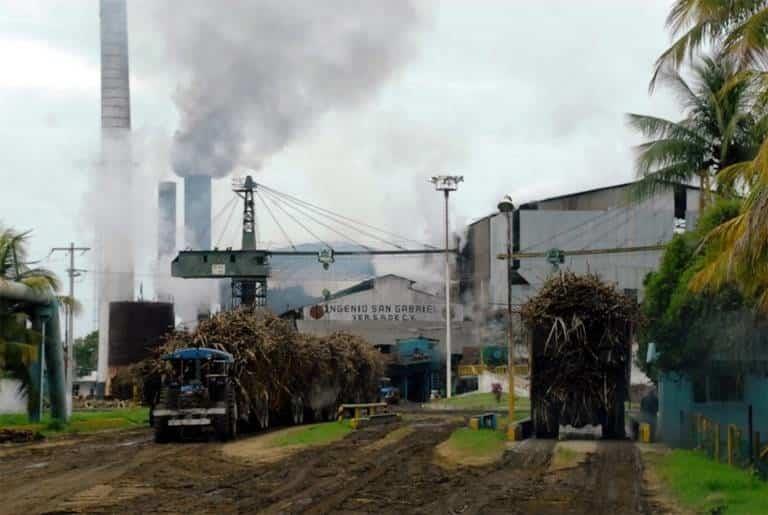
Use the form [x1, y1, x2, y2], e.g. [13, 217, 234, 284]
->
[0, 281, 67, 421]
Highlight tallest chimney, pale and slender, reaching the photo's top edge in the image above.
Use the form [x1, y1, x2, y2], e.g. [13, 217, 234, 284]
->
[94, 0, 134, 388]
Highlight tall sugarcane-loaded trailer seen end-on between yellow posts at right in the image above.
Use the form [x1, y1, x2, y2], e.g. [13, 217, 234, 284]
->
[522, 273, 639, 437]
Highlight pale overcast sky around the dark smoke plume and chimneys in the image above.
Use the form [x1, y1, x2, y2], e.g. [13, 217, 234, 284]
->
[0, 0, 679, 334]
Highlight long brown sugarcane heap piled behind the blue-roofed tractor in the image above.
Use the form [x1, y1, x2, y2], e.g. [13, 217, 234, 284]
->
[142, 308, 383, 426]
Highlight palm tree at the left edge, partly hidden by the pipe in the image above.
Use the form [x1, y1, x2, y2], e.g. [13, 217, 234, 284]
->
[0, 227, 59, 400]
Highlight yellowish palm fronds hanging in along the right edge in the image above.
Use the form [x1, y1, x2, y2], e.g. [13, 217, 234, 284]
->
[651, 0, 768, 313]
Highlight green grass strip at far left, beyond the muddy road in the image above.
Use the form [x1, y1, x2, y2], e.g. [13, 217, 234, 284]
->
[0, 407, 149, 436]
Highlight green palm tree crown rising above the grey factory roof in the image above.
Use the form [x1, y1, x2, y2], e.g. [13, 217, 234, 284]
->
[628, 57, 768, 210]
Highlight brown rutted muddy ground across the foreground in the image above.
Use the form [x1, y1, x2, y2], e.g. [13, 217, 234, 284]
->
[0, 414, 665, 514]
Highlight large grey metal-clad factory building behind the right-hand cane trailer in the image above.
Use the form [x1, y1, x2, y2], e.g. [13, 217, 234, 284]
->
[459, 183, 699, 374]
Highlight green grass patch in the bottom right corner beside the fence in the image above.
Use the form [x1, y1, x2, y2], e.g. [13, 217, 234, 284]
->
[650, 450, 768, 515]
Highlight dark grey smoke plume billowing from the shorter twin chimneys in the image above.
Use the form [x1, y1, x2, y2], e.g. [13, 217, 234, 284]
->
[156, 0, 422, 177]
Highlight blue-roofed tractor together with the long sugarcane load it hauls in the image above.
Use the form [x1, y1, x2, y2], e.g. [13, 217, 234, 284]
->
[141, 308, 383, 441]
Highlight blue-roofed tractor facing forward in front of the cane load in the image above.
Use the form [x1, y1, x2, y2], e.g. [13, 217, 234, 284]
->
[150, 347, 238, 443]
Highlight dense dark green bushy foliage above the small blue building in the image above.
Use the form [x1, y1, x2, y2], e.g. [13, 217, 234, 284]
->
[637, 200, 758, 379]
